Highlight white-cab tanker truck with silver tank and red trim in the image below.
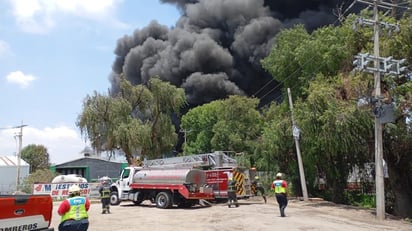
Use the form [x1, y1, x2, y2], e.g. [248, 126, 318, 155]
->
[110, 167, 213, 209]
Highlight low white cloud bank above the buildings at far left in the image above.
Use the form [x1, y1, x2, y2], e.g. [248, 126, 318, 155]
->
[0, 126, 85, 164]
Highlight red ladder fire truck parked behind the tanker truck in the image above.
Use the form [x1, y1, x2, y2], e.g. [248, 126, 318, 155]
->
[143, 151, 254, 201]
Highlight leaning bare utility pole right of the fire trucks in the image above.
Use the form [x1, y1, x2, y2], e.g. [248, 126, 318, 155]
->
[288, 88, 309, 201]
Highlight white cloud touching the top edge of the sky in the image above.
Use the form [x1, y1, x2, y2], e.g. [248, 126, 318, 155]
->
[10, 0, 124, 33]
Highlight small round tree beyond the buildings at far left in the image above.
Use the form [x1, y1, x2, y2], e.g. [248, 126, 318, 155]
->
[21, 144, 50, 173]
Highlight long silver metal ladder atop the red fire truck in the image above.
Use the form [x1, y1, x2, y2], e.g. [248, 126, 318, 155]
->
[143, 151, 237, 168]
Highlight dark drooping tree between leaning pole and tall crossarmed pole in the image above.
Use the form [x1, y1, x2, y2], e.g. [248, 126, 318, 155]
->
[294, 75, 373, 203]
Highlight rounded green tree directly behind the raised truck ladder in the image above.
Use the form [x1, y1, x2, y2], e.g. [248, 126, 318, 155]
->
[181, 96, 262, 156]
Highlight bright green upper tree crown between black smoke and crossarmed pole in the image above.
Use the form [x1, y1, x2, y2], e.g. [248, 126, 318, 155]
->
[262, 25, 355, 97]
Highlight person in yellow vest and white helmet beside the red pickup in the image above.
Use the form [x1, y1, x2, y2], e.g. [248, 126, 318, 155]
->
[57, 184, 90, 231]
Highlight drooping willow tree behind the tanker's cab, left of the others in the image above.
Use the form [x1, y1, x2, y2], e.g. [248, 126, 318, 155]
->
[76, 78, 186, 164]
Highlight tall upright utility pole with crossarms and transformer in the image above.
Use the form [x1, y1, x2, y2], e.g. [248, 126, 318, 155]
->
[354, 0, 405, 220]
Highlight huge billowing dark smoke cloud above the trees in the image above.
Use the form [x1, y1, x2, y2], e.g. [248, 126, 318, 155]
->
[110, 0, 358, 107]
